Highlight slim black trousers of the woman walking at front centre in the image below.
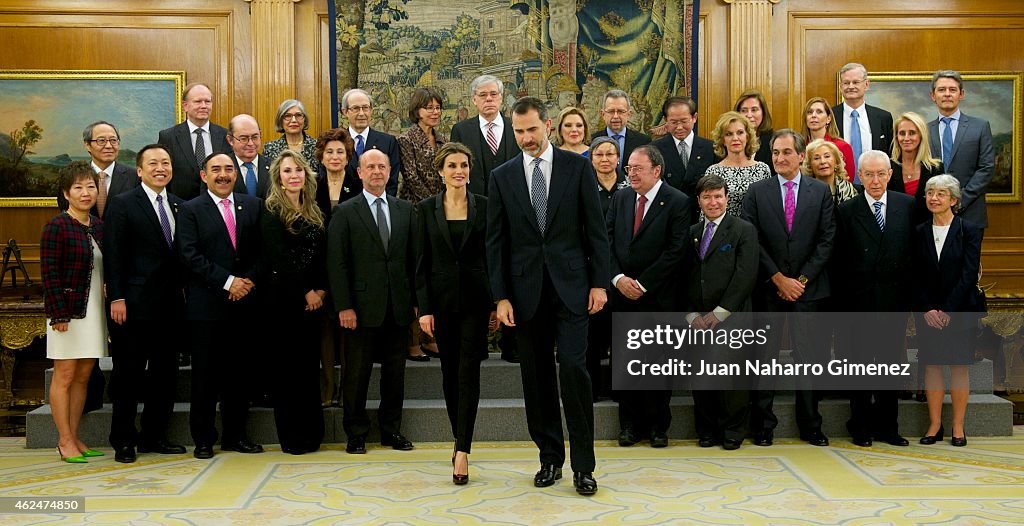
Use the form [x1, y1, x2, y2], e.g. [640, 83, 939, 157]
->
[434, 310, 490, 453]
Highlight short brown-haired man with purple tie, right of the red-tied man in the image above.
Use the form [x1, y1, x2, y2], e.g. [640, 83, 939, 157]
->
[684, 175, 760, 450]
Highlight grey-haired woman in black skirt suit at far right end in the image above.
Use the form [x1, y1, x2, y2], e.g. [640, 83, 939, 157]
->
[914, 174, 984, 446]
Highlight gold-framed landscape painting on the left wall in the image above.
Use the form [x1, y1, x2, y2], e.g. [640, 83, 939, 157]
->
[0, 70, 185, 207]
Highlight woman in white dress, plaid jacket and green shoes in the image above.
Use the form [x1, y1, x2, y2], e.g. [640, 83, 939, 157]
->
[40, 162, 106, 464]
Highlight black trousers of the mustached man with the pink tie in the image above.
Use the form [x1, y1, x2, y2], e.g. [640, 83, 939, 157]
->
[188, 320, 251, 445]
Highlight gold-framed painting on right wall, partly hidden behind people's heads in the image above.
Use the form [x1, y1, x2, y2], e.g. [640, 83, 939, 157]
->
[836, 72, 1024, 203]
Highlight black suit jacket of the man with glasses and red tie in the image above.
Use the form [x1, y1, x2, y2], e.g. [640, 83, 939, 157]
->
[606, 181, 692, 312]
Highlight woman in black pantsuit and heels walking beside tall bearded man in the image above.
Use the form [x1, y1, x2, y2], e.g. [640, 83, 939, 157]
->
[416, 142, 494, 484]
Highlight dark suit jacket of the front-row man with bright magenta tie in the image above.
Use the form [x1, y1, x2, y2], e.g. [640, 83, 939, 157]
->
[742, 176, 836, 301]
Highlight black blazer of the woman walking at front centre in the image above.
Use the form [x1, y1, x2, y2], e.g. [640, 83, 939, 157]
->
[416, 191, 494, 316]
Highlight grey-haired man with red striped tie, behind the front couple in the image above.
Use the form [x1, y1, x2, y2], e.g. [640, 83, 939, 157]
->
[452, 75, 519, 363]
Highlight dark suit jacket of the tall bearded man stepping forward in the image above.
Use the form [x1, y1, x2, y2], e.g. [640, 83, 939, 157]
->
[487, 144, 610, 321]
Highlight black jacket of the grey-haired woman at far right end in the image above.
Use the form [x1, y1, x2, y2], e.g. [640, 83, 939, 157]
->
[913, 216, 982, 312]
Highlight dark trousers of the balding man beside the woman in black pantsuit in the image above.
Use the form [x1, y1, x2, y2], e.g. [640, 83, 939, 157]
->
[342, 311, 409, 439]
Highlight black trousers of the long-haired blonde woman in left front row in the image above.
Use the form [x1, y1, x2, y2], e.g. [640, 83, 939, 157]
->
[267, 311, 324, 451]
